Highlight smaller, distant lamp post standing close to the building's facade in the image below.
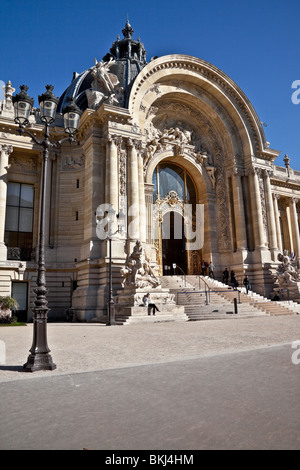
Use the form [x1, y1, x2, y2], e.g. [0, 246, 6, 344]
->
[107, 205, 125, 326]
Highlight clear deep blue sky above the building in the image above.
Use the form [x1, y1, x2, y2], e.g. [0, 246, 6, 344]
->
[0, 0, 300, 170]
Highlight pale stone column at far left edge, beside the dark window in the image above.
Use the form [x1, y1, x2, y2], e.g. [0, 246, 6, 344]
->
[0, 144, 13, 261]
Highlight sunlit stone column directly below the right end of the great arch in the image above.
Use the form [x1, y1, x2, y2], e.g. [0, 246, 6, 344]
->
[250, 168, 266, 250]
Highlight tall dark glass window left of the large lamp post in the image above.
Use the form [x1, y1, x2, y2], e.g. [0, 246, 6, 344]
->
[4, 183, 34, 261]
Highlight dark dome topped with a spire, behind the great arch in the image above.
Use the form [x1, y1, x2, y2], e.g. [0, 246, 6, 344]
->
[57, 19, 147, 112]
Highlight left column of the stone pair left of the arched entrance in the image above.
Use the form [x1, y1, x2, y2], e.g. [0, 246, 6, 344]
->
[105, 136, 119, 232]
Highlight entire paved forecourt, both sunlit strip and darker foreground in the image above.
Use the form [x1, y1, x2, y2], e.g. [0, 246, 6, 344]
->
[0, 316, 300, 452]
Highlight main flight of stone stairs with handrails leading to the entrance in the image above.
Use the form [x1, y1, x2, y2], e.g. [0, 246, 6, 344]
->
[162, 276, 300, 320]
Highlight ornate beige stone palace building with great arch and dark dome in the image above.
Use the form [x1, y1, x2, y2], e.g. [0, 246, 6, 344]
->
[0, 21, 300, 322]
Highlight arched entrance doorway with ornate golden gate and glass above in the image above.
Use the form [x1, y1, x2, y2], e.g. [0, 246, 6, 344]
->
[152, 160, 201, 275]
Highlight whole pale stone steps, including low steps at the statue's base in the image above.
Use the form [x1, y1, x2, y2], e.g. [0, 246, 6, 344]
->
[116, 276, 300, 325]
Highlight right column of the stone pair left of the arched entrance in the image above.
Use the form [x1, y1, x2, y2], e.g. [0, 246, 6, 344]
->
[127, 139, 140, 241]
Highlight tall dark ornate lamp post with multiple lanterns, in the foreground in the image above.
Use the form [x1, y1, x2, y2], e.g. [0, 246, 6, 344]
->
[12, 85, 82, 372]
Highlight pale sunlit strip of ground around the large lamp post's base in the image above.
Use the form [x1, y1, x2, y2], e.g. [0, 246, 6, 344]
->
[0, 315, 300, 382]
